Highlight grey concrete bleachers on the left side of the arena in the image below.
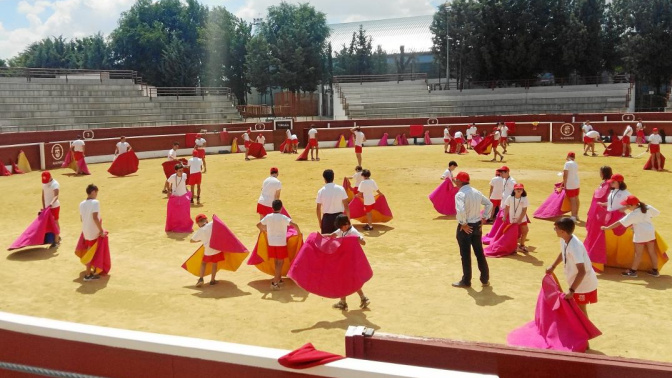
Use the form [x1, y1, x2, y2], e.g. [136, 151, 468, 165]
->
[0, 77, 242, 132]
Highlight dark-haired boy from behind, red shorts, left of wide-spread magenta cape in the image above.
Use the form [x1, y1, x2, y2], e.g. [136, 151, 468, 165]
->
[257, 200, 301, 290]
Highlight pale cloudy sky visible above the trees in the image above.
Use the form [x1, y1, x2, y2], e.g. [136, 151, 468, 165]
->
[0, 0, 443, 59]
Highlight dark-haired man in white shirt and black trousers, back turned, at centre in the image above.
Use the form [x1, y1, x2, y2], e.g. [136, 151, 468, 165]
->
[315, 169, 350, 234]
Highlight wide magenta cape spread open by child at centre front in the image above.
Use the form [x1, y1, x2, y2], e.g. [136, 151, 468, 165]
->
[288, 233, 373, 298]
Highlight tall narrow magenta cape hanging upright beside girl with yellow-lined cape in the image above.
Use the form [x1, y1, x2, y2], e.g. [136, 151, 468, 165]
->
[583, 181, 609, 266]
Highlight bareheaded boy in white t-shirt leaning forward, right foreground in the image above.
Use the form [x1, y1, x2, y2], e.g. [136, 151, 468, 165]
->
[546, 217, 597, 317]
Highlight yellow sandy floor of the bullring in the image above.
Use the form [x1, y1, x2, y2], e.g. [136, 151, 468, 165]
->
[0, 143, 672, 362]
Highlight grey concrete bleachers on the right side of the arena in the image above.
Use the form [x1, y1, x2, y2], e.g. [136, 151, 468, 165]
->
[335, 80, 630, 119]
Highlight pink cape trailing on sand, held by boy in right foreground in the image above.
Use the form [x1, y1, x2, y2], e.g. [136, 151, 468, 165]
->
[506, 274, 602, 352]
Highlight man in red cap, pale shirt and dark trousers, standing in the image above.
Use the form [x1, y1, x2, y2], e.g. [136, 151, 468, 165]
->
[453, 172, 492, 288]
